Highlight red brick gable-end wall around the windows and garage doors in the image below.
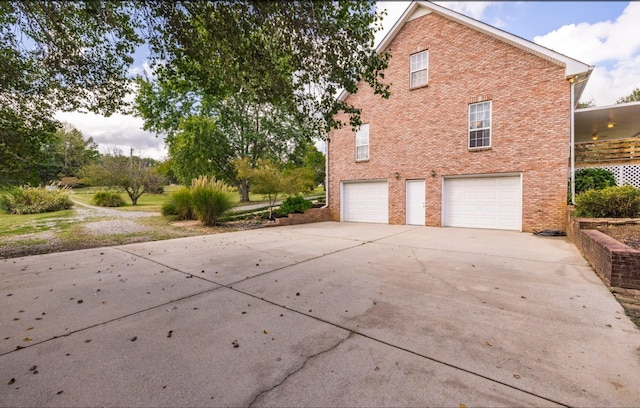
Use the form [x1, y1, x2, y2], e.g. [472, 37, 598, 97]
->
[328, 13, 570, 231]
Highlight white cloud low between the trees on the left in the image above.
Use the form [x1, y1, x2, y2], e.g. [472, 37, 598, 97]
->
[56, 112, 167, 160]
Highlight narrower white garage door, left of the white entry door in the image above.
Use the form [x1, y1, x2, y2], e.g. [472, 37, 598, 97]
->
[342, 181, 389, 224]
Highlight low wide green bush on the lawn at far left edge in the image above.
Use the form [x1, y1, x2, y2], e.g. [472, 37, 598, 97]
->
[0, 187, 73, 214]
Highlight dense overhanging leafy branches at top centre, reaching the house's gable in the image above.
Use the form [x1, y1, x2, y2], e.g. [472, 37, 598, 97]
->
[140, 0, 389, 136]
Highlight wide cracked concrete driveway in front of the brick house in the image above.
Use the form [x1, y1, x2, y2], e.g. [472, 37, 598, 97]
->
[0, 222, 640, 407]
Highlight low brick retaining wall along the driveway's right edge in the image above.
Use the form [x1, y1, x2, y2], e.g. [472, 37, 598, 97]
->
[567, 207, 640, 289]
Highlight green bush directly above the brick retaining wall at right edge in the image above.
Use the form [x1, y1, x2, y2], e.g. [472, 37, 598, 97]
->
[575, 185, 640, 218]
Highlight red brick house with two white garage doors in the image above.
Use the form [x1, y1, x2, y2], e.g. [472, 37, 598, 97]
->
[327, 1, 593, 231]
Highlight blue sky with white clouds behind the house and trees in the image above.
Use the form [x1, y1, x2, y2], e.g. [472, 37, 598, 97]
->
[56, 1, 640, 160]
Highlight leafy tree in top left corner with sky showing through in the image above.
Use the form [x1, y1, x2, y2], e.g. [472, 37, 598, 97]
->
[0, 0, 142, 184]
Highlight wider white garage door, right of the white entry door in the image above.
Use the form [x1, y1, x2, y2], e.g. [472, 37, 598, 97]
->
[442, 176, 522, 231]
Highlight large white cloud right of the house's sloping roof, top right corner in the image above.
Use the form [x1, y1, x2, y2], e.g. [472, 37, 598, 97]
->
[533, 2, 640, 106]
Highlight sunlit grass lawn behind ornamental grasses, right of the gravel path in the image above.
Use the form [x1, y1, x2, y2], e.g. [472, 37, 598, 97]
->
[73, 185, 324, 212]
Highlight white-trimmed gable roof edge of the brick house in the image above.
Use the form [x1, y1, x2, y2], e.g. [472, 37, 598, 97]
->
[338, 1, 594, 103]
